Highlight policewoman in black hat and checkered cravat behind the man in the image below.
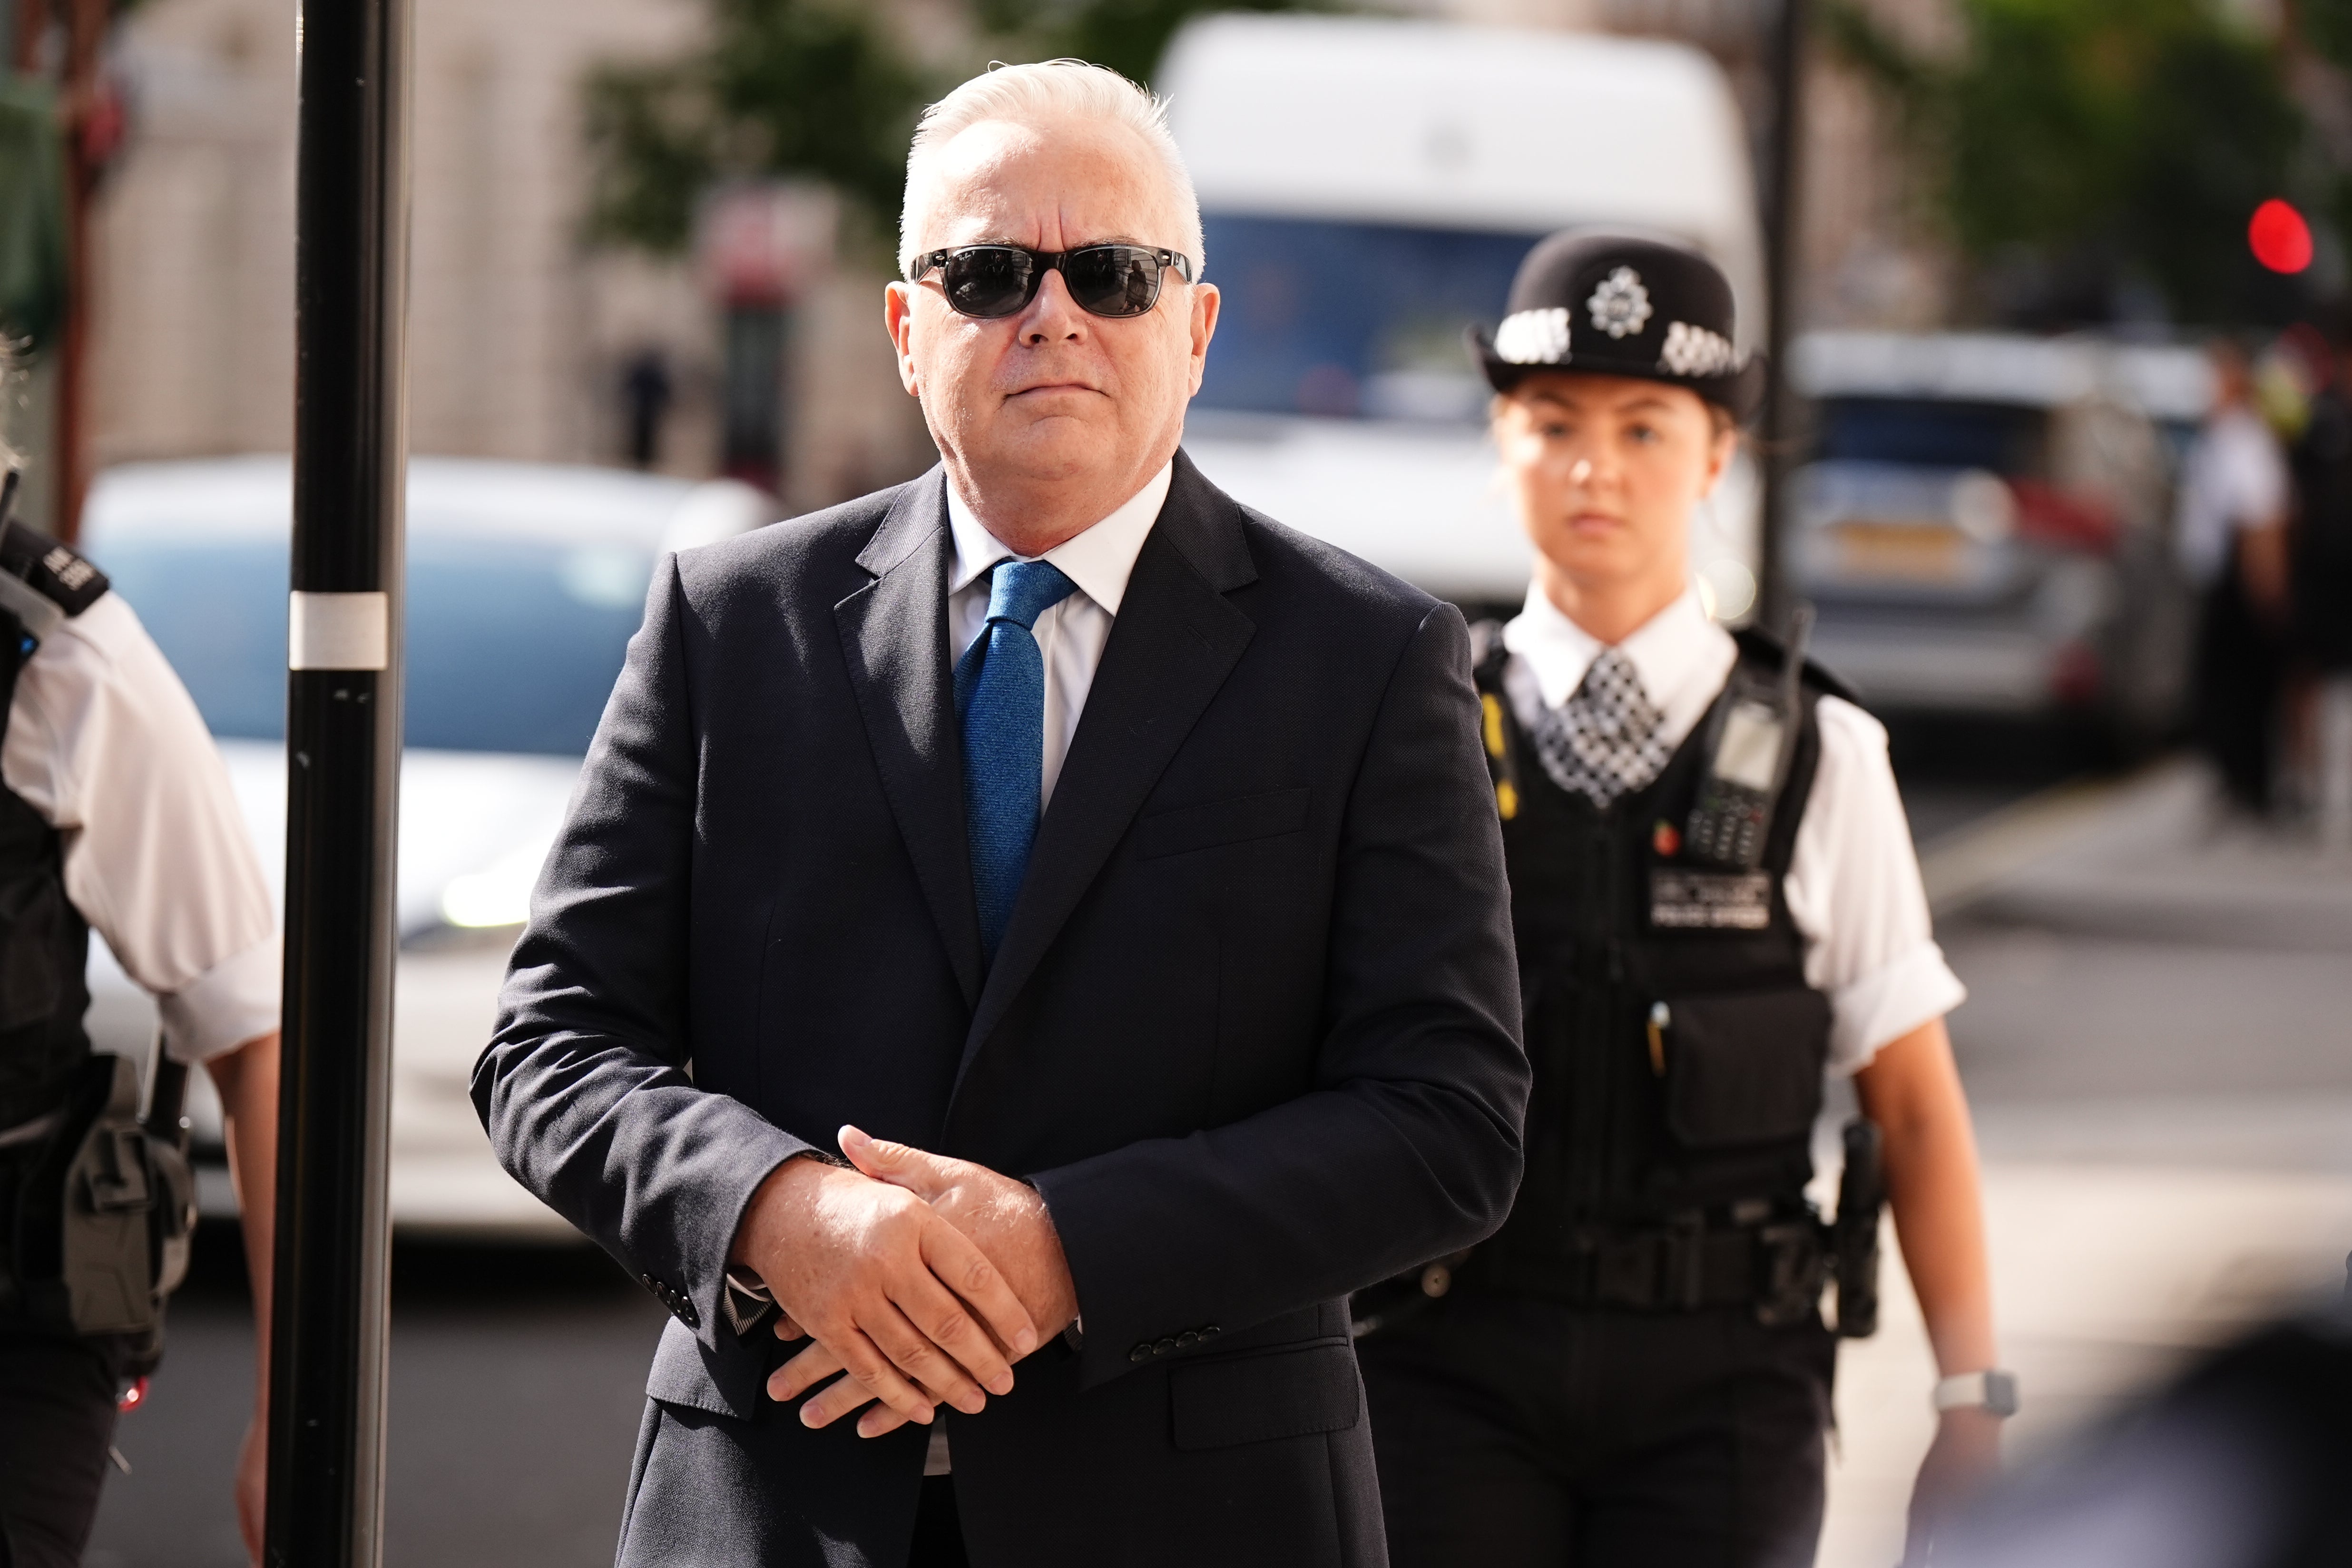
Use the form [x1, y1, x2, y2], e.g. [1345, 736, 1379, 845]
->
[1360, 233, 2013, 1568]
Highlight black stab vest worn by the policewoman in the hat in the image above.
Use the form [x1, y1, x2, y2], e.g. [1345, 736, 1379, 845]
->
[1472, 627, 1834, 1279]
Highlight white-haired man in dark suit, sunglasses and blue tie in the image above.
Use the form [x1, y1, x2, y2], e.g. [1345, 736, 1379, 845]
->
[475, 63, 1527, 1568]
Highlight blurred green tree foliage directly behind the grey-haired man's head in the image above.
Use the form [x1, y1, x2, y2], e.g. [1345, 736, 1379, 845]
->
[586, 0, 1324, 252]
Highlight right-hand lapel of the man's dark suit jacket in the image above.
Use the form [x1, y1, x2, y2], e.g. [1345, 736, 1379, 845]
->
[964, 451, 1256, 1069]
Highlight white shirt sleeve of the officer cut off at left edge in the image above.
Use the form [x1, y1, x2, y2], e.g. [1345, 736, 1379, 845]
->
[0, 592, 280, 1063]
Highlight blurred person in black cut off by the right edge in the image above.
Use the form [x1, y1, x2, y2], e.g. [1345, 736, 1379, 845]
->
[2289, 324, 2352, 851]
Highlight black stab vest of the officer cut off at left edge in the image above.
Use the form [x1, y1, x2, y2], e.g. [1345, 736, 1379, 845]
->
[0, 522, 106, 1131]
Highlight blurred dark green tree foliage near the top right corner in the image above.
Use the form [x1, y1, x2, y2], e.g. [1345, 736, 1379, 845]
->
[1825, 0, 2305, 322]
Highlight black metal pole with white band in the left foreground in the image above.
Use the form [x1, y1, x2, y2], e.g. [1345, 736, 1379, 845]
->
[264, 0, 409, 1568]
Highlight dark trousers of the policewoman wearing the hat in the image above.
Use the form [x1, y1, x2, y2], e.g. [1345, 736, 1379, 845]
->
[1357, 1291, 1837, 1568]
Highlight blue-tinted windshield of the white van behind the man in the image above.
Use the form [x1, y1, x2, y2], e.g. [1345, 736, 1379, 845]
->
[1195, 212, 1543, 423]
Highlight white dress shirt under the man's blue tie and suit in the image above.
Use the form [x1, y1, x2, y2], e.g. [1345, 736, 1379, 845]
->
[948, 465, 1176, 811]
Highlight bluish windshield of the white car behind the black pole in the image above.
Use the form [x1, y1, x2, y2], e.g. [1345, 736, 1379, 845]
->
[94, 531, 654, 757]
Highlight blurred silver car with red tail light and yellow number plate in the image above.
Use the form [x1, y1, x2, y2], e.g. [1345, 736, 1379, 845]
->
[1787, 332, 2211, 752]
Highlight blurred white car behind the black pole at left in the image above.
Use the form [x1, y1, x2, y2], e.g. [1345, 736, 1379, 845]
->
[82, 456, 776, 1239]
